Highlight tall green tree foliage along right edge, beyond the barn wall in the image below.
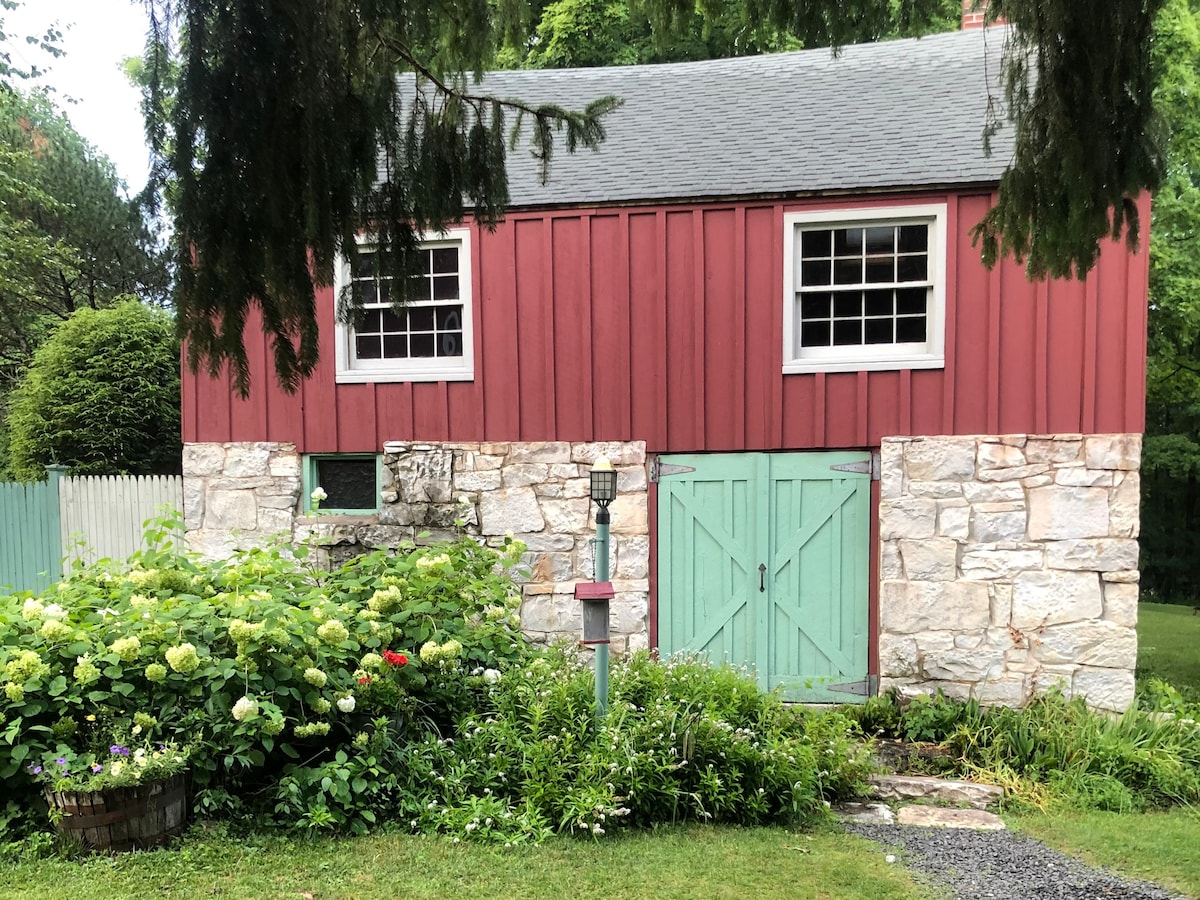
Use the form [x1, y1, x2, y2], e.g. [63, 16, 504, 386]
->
[1141, 0, 1200, 602]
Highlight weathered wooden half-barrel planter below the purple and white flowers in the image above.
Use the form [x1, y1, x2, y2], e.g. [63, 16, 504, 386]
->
[46, 773, 187, 853]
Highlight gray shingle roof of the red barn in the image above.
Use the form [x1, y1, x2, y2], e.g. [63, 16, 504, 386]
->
[474, 29, 1012, 206]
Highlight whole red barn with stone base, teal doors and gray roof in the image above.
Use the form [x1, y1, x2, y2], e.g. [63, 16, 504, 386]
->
[184, 24, 1148, 709]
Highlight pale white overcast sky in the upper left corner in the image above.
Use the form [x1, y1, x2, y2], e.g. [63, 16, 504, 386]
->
[5, 0, 149, 193]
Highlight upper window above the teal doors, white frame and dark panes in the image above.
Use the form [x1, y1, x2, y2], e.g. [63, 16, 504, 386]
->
[784, 205, 946, 372]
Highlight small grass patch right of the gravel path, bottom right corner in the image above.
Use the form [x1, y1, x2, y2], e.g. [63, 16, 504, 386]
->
[1004, 809, 1200, 896]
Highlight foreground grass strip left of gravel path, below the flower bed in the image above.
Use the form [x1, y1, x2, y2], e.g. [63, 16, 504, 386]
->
[0, 827, 928, 900]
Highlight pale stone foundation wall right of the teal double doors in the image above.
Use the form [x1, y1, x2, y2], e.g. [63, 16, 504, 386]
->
[880, 434, 1141, 710]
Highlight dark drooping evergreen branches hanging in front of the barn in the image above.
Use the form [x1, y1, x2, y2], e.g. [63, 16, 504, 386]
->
[145, 0, 1164, 392]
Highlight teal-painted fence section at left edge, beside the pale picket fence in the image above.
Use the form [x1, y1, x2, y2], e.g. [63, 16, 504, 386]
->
[0, 470, 62, 592]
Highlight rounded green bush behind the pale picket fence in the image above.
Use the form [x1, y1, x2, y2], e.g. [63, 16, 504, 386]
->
[8, 296, 182, 480]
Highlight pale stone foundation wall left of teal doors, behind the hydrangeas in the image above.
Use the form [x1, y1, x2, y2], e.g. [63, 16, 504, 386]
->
[184, 442, 650, 652]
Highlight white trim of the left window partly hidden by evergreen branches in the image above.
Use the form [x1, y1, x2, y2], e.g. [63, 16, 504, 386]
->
[334, 228, 475, 384]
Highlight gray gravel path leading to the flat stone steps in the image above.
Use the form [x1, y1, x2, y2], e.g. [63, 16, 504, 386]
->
[846, 823, 1187, 900]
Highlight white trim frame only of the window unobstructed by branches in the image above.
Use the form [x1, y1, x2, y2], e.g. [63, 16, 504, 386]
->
[784, 203, 947, 374]
